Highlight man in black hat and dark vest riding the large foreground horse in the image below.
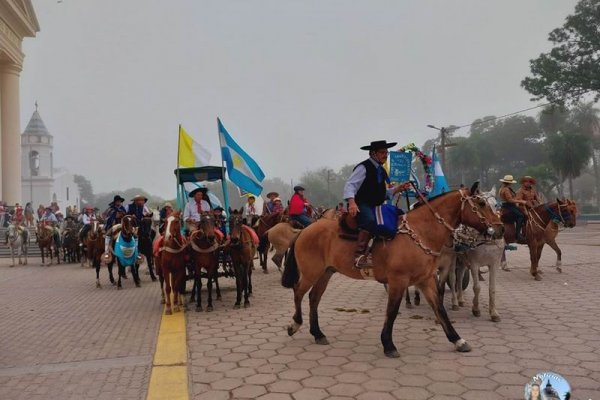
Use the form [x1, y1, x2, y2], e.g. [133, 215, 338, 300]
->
[344, 140, 410, 268]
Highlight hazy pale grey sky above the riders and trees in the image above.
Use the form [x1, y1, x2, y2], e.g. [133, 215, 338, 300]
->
[21, 0, 576, 198]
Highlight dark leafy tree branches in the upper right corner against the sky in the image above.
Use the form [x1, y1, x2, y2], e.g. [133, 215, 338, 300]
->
[521, 0, 600, 104]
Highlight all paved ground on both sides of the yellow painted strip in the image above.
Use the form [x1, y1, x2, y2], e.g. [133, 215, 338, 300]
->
[0, 227, 600, 400]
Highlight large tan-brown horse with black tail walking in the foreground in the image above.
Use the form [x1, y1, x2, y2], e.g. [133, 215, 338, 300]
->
[282, 184, 503, 357]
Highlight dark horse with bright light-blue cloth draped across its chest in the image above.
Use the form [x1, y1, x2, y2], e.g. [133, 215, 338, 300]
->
[113, 215, 141, 289]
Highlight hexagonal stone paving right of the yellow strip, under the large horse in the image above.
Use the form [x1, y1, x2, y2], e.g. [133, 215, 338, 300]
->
[188, 227, 600, 400]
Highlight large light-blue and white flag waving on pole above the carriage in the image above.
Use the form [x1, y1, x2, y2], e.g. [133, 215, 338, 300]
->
[217, 118, 265, 196]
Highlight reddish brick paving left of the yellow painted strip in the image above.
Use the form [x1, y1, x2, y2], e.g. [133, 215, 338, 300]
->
[0, 259, 161, 400]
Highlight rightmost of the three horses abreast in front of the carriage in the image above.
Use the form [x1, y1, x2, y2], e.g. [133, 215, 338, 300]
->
[227, 213, 257, 308]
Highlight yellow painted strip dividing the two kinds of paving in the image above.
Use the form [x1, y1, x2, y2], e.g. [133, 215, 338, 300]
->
[147, 312, 189, 400]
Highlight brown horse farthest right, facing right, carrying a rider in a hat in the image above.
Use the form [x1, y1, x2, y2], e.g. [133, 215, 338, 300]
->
[504, 199, 577, 281]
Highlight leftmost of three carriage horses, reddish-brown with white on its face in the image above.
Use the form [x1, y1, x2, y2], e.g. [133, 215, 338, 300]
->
[157, 211, 188, 315]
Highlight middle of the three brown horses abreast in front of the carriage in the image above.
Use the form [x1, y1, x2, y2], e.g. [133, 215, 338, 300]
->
[190, 213, 221, 311]
